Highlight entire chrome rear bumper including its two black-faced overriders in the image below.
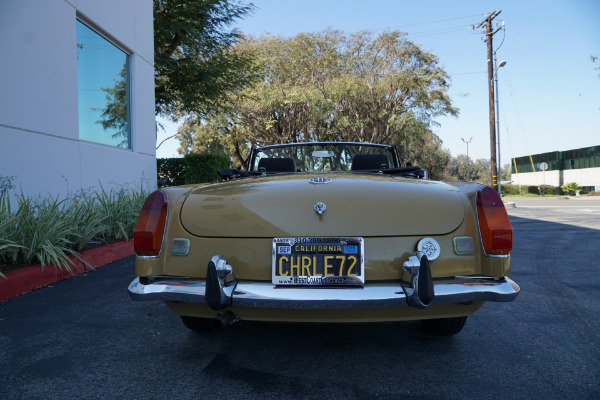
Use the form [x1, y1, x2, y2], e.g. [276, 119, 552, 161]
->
[128, 252, 520, 311]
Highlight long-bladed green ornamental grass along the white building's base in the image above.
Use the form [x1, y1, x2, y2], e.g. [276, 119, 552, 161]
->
[0, 185, 149, 276]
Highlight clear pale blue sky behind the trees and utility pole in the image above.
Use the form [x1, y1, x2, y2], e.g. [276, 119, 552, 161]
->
[157, 0, 600, 165]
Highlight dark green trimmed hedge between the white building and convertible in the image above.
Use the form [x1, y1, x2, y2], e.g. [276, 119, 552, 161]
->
[156, 154, 231, 186]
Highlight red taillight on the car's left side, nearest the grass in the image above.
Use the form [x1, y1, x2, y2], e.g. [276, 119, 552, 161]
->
[133, 190, 169, 256]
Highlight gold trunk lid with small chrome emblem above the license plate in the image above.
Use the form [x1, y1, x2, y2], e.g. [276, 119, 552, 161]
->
[181, 173, 465, 238]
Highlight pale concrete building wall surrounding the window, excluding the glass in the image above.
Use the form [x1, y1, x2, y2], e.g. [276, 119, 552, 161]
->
[0, 0, 156, 195]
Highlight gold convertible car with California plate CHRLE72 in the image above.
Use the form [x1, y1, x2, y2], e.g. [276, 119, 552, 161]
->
[128, 142, 520, 335]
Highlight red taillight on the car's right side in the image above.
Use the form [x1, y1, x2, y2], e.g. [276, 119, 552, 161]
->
[477, 186, 512, 255]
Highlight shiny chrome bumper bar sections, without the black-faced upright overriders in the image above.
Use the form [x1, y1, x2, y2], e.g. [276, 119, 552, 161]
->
[128, 277, 520, 309]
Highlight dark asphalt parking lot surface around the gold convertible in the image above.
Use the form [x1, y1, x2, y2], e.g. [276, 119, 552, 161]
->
[0, 199, 600, 399]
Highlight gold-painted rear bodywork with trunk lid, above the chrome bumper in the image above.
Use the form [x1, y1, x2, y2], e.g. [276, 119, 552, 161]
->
[136, 176, 510, 282]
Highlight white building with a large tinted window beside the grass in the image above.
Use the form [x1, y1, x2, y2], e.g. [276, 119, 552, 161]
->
[0, 0, 156, 196]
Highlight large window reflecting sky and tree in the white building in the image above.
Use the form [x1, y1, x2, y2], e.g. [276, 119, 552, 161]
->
[77, 20, 131, 149]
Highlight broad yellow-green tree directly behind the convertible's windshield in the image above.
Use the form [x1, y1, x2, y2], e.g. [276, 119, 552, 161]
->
[176, 30, 457, 169]
